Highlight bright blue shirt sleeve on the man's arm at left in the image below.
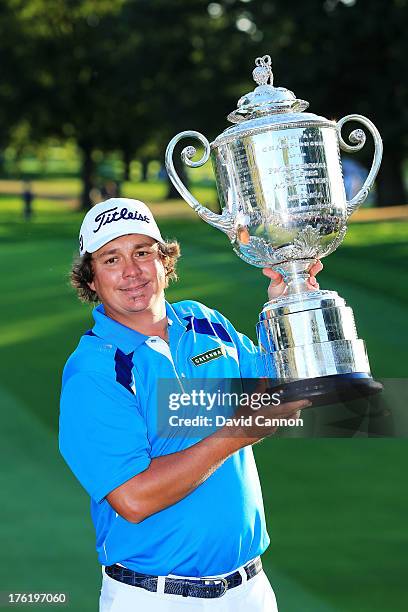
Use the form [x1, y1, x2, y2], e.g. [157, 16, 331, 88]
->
[59, 372, 150, 503]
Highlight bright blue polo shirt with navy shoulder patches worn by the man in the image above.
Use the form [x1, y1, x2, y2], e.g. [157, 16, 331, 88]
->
[60, 301, 269, 576]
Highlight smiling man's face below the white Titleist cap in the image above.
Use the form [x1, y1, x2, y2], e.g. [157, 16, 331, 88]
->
[89, 234, 166, 321]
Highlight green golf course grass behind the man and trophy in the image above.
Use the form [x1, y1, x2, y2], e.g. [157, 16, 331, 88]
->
[0, 194, 408, 612]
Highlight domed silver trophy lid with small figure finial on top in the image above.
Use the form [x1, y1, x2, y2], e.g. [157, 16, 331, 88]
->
[228, 55, 309, 123]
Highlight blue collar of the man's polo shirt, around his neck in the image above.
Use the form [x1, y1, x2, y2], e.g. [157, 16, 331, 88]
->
[92, 302, 187, 355]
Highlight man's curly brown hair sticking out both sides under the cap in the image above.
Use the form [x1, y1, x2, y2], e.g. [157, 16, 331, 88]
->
[70, 240, 180, 303]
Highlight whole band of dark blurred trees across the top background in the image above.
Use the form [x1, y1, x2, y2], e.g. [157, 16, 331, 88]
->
[4, 0, 408, 207]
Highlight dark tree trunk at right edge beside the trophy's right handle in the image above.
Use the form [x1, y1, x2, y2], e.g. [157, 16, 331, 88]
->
[377, 149, 407, 206]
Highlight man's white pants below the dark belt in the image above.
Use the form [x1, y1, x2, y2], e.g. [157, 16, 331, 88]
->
[99, 568, 278, 612]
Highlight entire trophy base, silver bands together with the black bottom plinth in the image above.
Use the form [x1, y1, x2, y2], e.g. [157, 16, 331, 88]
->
[257, 290, 382, 406]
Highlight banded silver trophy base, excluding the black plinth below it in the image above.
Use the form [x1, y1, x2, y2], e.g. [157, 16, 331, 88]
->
[257, 290, 371, 382]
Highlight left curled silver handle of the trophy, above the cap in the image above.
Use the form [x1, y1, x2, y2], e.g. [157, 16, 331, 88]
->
[165, 130, 234, 237]
